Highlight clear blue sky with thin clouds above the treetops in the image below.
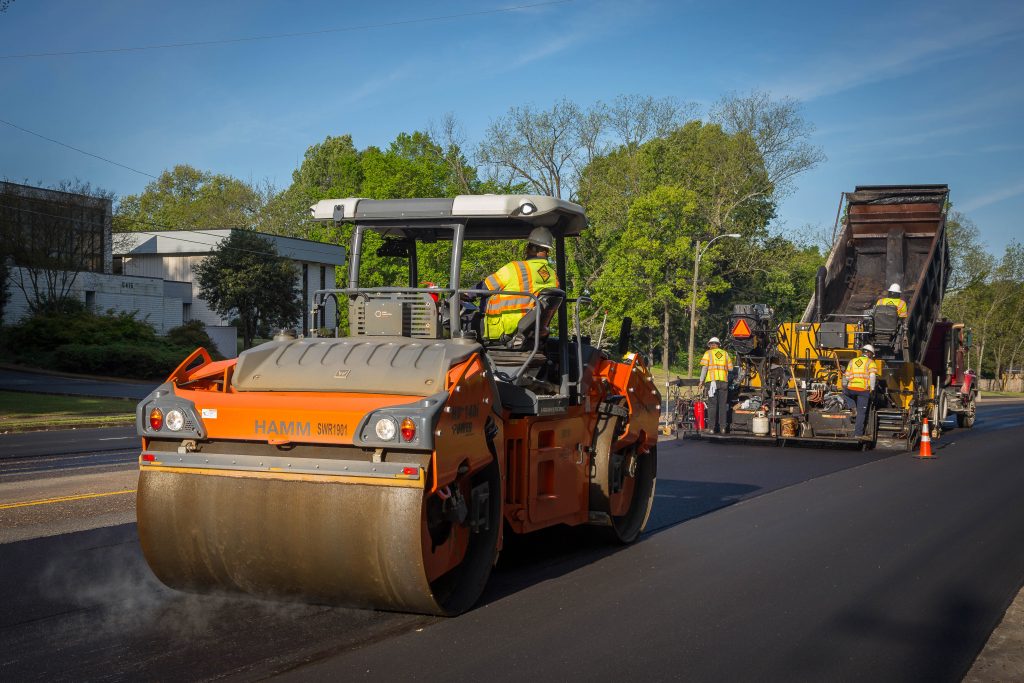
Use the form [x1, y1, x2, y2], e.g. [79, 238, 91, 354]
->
[0, 0, 1024, 253]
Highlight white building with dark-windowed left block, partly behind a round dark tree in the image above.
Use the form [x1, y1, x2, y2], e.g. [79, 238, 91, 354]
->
[0, 182, 345, 357]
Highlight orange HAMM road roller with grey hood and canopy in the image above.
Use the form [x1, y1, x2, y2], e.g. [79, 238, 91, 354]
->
[137, 195, 660, 615]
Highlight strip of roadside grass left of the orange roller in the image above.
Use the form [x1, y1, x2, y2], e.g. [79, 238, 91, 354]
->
[0, 391, 137, 431]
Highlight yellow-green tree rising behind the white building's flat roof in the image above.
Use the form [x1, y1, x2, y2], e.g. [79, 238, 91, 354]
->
[114, 164, 266, 232]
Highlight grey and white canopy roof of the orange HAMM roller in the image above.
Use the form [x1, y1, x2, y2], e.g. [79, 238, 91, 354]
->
[309, 195, 587, 240]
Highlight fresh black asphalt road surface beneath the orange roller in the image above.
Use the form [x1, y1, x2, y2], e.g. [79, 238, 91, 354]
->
[0, 403, 1024, 681]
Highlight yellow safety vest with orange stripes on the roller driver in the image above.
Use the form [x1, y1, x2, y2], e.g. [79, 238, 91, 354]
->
[483, 258, 558, 339]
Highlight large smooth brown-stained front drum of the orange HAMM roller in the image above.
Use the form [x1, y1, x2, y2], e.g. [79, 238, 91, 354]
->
[137, 465, 501, 615]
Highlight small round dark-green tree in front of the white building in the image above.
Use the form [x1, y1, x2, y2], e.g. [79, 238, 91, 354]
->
[195, 230, 303, 348]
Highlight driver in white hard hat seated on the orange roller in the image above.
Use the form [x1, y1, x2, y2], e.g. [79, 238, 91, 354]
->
[477, 227, 559, 340]
